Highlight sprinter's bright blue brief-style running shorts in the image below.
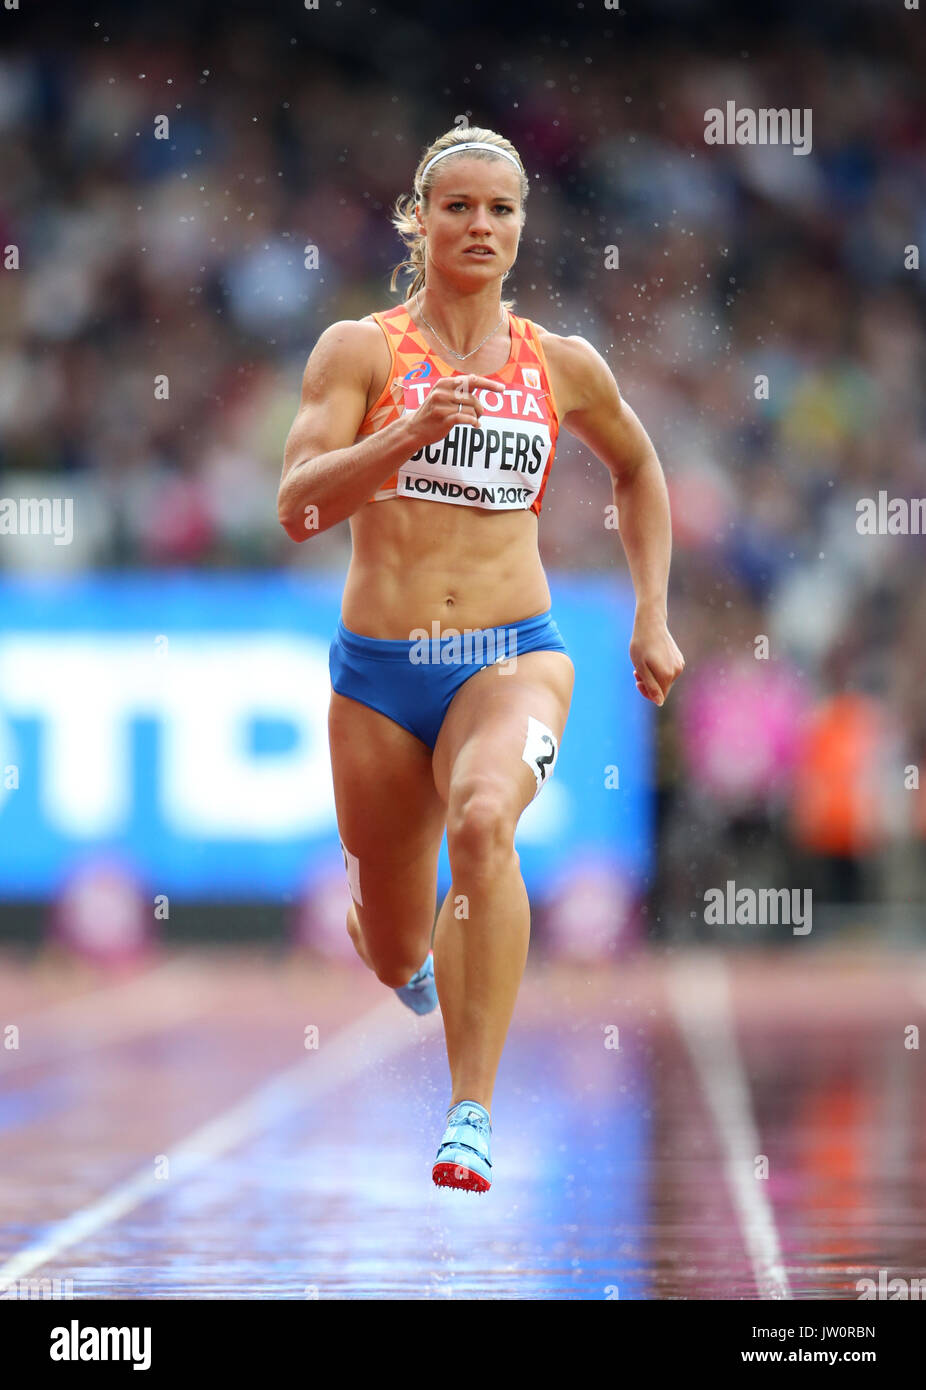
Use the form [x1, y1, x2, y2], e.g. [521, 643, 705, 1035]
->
[328, 609, 569, 749]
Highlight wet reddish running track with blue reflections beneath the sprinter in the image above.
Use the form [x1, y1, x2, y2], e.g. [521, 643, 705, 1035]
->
[0, 942, 926, 1300]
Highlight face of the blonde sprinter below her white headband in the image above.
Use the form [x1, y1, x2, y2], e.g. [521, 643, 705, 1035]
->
[416, 156, 521, 279]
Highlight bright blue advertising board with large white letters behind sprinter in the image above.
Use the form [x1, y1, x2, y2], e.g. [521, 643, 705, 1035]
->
[0, 571, 652, 899]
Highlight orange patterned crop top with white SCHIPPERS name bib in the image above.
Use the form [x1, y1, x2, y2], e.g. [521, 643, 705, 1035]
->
[357, 304, 559, 516]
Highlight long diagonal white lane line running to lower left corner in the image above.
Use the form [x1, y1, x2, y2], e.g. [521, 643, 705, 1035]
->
[0, 998, 441, 1290]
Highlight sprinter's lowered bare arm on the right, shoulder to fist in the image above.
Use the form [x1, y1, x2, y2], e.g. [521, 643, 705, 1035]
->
[556, 336, 685, 705]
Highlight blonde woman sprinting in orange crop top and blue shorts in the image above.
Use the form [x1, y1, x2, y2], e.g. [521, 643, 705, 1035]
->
[278, 128, 684, 1191]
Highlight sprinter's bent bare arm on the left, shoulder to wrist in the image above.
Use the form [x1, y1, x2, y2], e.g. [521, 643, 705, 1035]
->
[277, 318, 419, 541]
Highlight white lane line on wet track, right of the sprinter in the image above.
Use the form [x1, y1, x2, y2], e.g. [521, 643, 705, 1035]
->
[667, 951, 794, 1298]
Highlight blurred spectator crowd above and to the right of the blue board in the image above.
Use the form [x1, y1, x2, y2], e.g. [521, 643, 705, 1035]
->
[0, 6, 926, 924]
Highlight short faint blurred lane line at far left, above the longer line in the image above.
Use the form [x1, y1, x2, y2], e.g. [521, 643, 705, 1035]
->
[0, 958, 207, 1083]
